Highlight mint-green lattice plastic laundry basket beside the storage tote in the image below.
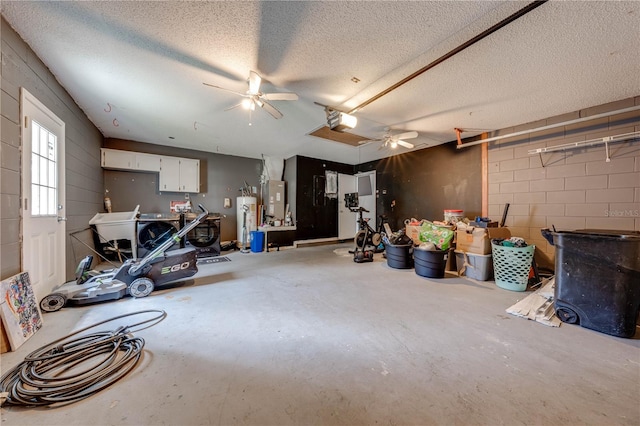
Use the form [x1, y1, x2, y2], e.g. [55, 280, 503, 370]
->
[491, 242, 536, 291]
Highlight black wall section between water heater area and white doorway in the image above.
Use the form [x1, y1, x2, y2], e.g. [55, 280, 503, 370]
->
[285, 156, 354, 240]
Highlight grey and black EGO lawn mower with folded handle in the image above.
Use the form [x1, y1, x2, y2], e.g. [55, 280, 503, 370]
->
[40, 205, 209, 312]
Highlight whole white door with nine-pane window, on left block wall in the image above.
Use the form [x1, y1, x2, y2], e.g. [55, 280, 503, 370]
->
[20, 88, 66, 299]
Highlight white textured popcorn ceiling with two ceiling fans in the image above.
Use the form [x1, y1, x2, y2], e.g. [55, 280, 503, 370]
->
[0, 0, 640, 164]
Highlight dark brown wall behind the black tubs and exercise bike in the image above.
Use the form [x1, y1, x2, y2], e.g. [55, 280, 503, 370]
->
[356, 142, 480, 231]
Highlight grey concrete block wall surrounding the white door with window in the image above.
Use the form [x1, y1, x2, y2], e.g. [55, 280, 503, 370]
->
[0, 18, 104, 279]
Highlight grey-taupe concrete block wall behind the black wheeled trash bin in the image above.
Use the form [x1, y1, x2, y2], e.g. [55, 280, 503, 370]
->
[488, 96, 640, 266]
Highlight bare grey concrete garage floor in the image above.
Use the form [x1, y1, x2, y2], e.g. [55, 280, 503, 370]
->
[1, 244, 640, 425]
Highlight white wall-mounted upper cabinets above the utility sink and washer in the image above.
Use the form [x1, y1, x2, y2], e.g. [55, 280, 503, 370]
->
[101, 148, 200, 192]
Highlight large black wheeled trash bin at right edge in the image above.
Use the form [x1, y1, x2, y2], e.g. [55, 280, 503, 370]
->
[542, 230, 640, 337]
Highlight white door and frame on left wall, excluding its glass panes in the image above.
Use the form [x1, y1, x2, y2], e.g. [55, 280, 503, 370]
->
[20, 87, 66, 299]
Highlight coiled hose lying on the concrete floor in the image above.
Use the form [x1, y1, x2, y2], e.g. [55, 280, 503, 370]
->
[0, 310, 167, 406]
